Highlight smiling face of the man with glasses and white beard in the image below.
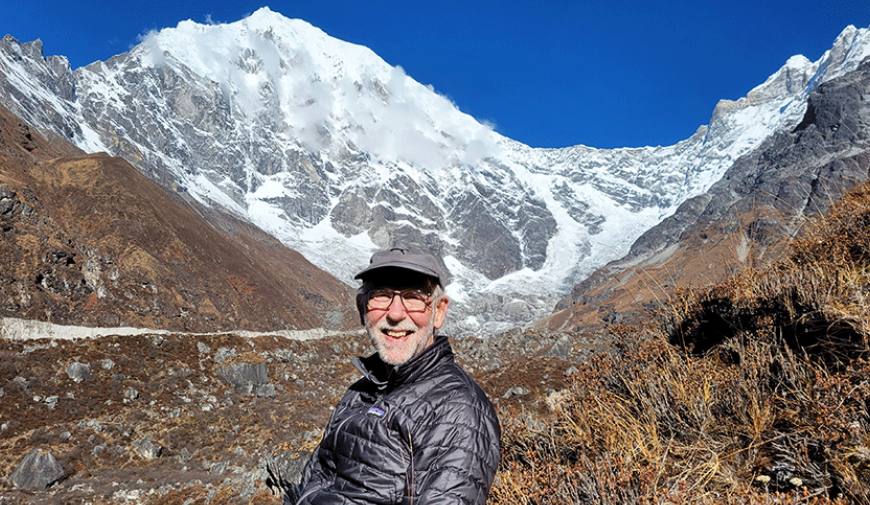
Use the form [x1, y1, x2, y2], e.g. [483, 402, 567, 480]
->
[365, 270, 449, 365]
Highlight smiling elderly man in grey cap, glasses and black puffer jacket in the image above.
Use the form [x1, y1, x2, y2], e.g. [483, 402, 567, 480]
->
[285, 248, 500, 505]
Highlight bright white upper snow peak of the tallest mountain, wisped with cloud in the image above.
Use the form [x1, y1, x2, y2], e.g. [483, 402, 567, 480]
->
[125, 8, 496, 169]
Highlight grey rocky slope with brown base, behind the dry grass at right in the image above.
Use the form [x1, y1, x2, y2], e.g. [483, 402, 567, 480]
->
[546, 59, 870, 328]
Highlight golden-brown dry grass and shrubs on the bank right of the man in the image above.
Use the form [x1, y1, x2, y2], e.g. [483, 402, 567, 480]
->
[491, 186, 870, 505]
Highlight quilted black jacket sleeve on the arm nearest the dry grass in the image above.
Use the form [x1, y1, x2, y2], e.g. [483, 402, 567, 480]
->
[405, 399, 501, 505]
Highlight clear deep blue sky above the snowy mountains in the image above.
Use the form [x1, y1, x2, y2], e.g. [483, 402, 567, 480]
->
[0, 0, 870, 147]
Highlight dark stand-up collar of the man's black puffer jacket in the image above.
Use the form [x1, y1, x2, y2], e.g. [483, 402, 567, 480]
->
[353, 335, 453, 390]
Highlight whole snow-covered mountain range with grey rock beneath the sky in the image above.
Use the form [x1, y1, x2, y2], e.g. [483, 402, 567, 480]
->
[0, 8, 870, 332]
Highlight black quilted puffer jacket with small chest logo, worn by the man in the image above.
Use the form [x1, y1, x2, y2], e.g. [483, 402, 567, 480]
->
[285, 336, 501, 505]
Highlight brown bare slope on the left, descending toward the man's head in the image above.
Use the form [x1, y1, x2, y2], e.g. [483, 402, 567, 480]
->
[0, 104, 354, 331]
